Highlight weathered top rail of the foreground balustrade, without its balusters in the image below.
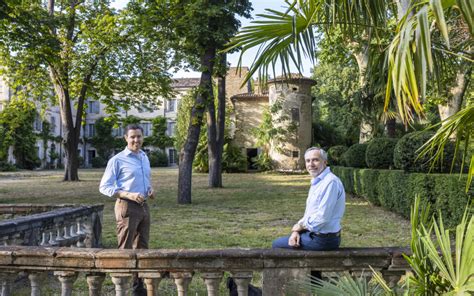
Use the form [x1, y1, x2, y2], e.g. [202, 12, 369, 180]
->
[0, 246, 410, 272]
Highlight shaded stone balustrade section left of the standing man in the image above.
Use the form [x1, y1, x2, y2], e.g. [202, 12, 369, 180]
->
[0, 204, 104, 248]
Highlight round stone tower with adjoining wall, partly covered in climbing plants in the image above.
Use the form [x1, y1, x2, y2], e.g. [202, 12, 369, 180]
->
[231, 75, 315, 171]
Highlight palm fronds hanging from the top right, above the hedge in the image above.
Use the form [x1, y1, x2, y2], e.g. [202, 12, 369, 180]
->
[229, 0, 474, 186]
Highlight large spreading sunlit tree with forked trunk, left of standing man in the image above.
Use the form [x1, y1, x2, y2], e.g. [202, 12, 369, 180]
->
[0, 0, 170, 181]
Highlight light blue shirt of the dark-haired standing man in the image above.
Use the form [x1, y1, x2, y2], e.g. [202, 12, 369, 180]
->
[99, 148, 151, 199]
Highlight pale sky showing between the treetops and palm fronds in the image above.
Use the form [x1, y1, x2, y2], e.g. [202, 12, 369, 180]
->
[112, 0, 311, 78]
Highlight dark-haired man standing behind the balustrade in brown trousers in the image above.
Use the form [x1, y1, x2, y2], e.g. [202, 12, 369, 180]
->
[99, 124, 154, 295]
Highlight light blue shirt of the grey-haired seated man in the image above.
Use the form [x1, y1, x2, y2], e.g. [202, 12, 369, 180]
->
[298, 167, 346, 233]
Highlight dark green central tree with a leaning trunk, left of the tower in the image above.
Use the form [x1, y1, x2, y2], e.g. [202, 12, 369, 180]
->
[148, 0, 251, 204]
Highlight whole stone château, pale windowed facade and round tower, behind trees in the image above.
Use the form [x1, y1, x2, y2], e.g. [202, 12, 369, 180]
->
[0, 67, 314, 170]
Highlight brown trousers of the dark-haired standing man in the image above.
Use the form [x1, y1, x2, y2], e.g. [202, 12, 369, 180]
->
[115, 198, 150, 249]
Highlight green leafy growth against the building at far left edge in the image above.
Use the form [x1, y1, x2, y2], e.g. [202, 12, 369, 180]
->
[0, 98, 40, 170]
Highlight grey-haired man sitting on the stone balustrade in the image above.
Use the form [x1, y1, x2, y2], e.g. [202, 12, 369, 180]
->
[272, 147, 346, 251]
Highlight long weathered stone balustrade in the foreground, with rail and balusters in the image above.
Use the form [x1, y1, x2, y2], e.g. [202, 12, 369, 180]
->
[0, 246, 409, 296]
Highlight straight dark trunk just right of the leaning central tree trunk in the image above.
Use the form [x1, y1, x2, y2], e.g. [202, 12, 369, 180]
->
[207, 54, 227, 188]
